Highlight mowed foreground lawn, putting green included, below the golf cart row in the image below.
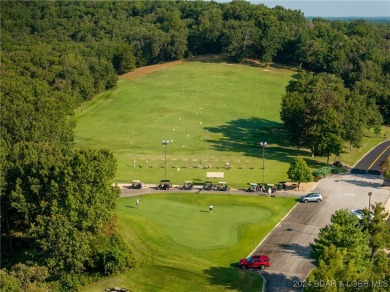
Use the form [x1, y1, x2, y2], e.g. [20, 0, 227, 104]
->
[85, 193, 296, 292]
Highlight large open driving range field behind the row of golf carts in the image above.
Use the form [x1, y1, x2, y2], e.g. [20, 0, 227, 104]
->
[76, 61, 390, 187]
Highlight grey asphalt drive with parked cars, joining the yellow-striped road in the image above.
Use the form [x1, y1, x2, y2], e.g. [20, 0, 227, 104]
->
[252, 141, 390, 292]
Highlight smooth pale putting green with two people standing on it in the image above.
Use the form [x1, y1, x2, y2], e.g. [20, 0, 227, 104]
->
[120, 194, 272, 249]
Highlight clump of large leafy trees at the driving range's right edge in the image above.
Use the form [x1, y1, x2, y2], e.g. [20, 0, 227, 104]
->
[280, 72, 384, 162]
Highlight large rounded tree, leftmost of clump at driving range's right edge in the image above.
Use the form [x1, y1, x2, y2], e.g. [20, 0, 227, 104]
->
[280, 73, 349, 160]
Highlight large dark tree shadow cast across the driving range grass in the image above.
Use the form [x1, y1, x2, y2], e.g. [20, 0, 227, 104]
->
[204, 117, 323, 167]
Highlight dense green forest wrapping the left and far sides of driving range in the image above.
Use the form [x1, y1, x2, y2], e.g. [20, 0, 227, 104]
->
[0, 1, 390, 290]
